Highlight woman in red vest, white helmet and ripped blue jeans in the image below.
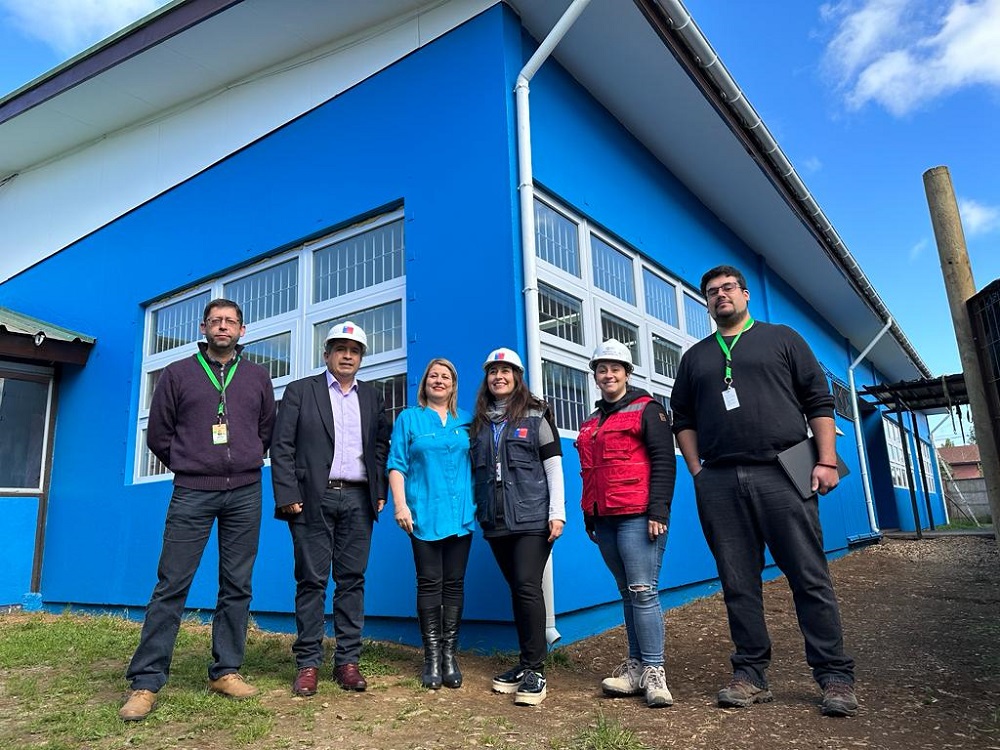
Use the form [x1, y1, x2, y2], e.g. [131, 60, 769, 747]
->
[576, 339, 677, 708]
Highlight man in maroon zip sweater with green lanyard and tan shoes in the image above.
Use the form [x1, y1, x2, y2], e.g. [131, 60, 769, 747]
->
[118, 299, 274, 721]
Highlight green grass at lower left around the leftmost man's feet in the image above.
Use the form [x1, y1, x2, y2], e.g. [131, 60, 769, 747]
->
[0, 614, 406, 750]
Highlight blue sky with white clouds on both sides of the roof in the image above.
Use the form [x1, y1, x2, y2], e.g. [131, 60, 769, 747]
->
[0, 0, 1000, 444]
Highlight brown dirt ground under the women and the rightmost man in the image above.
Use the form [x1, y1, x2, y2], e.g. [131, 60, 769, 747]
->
[246, 536, 1000, 750]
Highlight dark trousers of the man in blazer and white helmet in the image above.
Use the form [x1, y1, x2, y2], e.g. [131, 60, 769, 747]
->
[288, 487, 374, 669]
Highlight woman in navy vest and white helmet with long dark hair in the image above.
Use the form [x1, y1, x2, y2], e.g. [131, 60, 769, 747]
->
[470, 348, 566, 706]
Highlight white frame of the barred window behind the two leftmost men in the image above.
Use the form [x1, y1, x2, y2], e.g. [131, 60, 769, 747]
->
[132, 208, 407, 483]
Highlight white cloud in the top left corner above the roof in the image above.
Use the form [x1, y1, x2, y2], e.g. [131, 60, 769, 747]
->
[0, 0, 166, 58]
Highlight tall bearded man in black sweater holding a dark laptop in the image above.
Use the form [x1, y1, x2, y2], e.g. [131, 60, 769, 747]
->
[670, 266, 858, 716]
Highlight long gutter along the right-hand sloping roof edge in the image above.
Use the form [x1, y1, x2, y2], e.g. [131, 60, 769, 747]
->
[654, 0, 931, 378]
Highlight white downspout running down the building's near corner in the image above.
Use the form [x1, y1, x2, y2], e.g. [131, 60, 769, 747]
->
[514, 0, 590, 645]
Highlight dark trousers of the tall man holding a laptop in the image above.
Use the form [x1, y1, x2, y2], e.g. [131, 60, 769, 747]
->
[694, 463, 854, 687]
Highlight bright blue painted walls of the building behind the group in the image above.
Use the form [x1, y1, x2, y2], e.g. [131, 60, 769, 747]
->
[2, 7, 944, 648]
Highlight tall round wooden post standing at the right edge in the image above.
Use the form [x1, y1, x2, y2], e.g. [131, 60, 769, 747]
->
[924, 167, 1000, 542]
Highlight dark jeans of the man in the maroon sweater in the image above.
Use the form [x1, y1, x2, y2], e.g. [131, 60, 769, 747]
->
[125, 481, 261, 693]
